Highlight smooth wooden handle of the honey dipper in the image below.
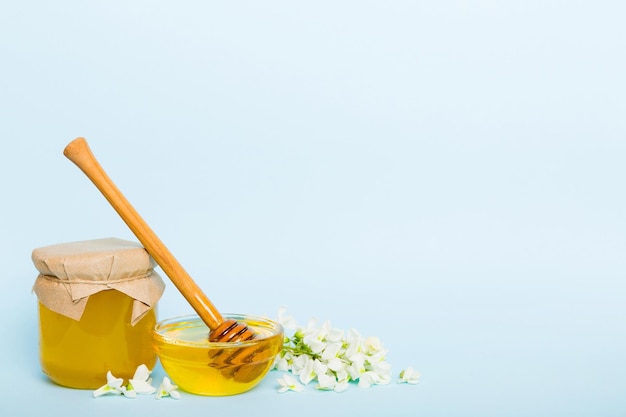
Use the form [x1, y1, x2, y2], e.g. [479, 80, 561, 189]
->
[63, 138, 224, 330]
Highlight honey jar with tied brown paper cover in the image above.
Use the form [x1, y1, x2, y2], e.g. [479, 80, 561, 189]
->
[32, 238, 165, 389]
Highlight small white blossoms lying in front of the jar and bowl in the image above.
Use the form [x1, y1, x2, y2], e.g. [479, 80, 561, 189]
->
[93, 364, 180, 399]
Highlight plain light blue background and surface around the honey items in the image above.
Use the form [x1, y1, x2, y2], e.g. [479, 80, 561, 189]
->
[0, 0, 626, 417]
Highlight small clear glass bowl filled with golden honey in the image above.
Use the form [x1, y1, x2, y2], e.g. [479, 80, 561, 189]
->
[153, 314, 283, 396]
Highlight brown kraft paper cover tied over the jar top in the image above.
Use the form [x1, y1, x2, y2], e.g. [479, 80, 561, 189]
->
[32, 238, 165, 325]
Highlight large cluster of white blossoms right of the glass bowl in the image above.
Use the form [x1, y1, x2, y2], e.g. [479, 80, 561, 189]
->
[274, 308, 404, 392]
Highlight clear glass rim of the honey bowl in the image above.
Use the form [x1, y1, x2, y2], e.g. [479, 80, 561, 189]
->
[152, 313, 284, 348]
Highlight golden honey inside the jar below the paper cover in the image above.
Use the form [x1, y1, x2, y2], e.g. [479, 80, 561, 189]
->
[39, 290, 156, 388]
